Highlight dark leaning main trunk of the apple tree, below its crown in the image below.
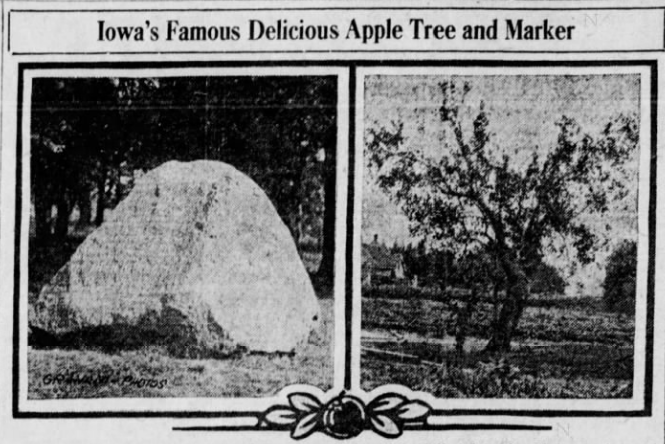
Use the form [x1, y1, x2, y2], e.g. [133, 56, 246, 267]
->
[485, 263, 529, 353]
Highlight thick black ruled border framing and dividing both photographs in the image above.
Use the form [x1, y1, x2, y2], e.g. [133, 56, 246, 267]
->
[12, 59, 658, 424]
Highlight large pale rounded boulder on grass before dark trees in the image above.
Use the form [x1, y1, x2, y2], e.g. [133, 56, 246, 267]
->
[29, 161, 319, 352]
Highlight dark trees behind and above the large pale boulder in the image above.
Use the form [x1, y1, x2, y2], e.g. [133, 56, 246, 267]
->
[31, 76, 337, 276]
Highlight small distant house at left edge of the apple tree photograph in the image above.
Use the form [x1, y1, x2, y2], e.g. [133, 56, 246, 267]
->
[362, 234, 406, 285]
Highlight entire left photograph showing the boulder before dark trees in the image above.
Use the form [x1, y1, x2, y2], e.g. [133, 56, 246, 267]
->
[22, 75, 338, 399]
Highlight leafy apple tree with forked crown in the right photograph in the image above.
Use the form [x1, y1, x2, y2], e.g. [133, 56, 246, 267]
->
[367, 81, 638, 352]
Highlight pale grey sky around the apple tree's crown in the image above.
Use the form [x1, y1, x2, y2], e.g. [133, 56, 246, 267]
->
[362, 74, 640, 292]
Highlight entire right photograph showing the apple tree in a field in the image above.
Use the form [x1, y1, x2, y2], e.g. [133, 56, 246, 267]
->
[360, 70, 648, 399]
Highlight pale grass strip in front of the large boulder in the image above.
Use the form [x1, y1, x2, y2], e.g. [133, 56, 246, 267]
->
[28, 299, 333, 399]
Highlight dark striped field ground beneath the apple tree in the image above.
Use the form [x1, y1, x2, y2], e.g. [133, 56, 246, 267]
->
[361, 298, 634, 399]
